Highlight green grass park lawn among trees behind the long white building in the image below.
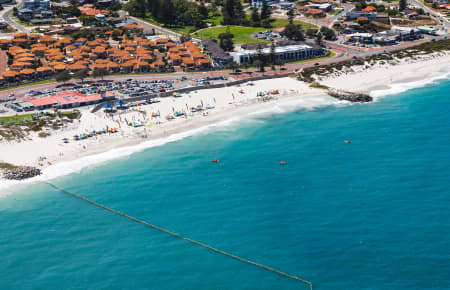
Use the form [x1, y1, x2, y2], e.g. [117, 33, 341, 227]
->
[192, 18, 317, 43]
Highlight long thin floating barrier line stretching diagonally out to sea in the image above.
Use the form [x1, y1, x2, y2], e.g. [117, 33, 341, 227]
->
[44, 182, 313, 290]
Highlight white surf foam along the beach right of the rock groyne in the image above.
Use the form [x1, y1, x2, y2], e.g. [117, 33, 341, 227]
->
[370, 69, 450, 100]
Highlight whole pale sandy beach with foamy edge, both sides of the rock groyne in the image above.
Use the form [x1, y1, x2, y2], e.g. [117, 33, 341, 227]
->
[0, 52, 450, 188]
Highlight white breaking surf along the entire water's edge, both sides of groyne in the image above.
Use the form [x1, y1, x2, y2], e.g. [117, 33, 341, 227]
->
[0, 71, 450, 196]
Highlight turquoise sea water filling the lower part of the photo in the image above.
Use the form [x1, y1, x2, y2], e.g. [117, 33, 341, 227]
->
[0, 80, 450, 289]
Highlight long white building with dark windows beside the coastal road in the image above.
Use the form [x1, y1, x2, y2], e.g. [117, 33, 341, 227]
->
[231, 44, 322, 64]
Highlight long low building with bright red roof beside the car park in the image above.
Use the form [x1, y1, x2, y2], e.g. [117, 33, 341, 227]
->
[23, 91, 115, 110]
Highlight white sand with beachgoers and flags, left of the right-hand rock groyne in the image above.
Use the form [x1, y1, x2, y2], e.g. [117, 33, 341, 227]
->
[0, 78, 330, 168]
